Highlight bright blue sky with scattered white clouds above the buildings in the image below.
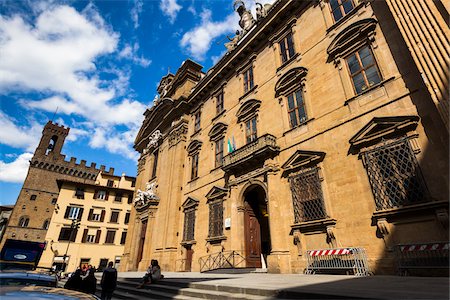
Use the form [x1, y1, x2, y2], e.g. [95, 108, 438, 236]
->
[0, 0, 273, 205]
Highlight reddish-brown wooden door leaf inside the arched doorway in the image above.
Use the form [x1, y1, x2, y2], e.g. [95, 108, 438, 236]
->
[244, 202, 261, 268]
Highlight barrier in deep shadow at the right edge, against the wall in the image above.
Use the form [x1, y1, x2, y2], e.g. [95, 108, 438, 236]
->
[397, 242, 450, 275]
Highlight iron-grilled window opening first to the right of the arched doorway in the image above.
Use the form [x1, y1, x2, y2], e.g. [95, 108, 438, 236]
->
[289, 166, 327, 223]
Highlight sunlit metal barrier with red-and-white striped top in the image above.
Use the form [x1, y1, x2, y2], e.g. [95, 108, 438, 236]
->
[305, 248, 370, 276]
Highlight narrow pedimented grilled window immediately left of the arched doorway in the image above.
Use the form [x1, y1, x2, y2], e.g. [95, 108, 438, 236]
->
[206, 186, 228, 244]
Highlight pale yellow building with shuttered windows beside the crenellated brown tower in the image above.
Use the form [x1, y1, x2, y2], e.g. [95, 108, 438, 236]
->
[39, 172, 135, 272]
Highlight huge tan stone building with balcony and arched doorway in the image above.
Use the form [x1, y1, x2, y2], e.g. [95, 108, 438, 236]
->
[121, 0, 450, 274]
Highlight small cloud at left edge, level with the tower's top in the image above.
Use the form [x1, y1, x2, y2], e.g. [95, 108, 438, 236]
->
[0, 111, 42, 151]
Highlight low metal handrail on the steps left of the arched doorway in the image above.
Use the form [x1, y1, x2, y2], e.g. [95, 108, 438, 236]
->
[198, 250, 245, 272]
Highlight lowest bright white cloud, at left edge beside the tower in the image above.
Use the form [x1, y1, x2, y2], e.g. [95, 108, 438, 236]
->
[0, 152, 33, 183]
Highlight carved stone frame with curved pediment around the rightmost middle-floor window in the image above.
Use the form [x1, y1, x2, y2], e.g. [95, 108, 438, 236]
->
[327, 18, 391, 102]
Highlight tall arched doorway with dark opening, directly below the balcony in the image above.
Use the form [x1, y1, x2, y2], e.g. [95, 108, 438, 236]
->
[244, 185, 271, 268]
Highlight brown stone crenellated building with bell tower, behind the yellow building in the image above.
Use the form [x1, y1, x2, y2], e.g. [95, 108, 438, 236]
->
[0, 121, 129, 249]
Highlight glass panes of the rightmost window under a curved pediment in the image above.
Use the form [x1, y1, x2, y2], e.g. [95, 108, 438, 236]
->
[346, 46, 381, 94]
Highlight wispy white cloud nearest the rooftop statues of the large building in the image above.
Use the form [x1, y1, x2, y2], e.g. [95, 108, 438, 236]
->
[180, 9, 239, 61]
